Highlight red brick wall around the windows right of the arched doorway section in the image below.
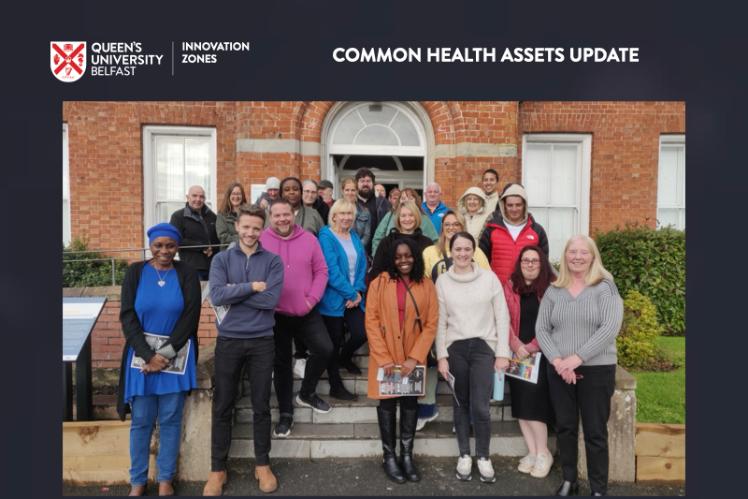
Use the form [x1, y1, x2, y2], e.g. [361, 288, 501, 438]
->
[512, 102, 686, 234]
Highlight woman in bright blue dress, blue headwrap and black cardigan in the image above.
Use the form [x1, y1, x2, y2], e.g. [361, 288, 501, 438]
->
[117, 223, 201, 496]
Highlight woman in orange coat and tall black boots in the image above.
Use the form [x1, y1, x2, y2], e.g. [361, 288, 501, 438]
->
[366, 238, 439, 483]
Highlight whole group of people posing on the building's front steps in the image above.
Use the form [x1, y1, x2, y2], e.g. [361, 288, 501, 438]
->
[118, 168, 623, 495]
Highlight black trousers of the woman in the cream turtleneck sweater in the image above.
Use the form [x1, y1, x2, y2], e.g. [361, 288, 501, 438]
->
[447, 338, 496, 458]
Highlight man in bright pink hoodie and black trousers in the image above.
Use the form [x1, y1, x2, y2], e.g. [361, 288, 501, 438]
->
[260, 199, 333, 437]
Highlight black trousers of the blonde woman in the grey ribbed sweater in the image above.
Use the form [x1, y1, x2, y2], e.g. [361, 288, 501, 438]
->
[548, 363, 616, 494]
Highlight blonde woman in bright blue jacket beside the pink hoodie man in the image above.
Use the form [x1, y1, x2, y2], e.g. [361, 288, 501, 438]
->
[319, 199, 366, 400]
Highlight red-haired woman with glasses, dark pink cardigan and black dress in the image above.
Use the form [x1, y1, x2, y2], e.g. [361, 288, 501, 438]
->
[504, 246, 555, 478]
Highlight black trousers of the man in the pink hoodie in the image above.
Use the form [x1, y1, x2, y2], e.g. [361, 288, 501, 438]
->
[273, 308, 333, 416]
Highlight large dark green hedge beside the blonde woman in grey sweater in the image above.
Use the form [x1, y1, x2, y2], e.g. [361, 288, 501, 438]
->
[596, 227, 686, 336]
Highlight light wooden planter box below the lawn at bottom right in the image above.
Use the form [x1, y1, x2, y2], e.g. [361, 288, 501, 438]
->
[636, 423, 686, 482]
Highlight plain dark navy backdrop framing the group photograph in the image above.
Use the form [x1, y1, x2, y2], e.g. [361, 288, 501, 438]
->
[0, 0, 748, 497]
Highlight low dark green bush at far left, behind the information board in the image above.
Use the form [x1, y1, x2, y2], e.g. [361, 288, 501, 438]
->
[62, 239, 127, 288]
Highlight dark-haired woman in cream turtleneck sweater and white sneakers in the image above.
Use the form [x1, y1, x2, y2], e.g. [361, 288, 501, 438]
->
[436, 232, 511, 483]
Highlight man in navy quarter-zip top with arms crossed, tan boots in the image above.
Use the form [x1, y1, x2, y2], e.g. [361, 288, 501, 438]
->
[203, 207, 283, 495]
